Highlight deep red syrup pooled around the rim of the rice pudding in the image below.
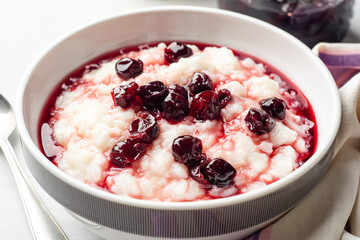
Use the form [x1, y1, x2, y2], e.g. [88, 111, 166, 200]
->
[38, 42, 318, 199]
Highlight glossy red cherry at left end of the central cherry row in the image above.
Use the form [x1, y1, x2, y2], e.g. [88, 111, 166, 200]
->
[112, 82, 139, 108]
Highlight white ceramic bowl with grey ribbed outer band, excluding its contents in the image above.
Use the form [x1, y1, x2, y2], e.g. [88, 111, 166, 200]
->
[16, 7, 340, 239]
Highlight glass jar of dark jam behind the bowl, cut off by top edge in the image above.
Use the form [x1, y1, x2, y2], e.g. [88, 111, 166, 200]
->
[218, 0, 354, 47]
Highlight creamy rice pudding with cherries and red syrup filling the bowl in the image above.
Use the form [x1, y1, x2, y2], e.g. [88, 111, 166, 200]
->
[39, 42, 316, 201]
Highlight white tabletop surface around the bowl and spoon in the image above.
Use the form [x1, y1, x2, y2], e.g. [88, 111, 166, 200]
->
[0, 0, 360, 240]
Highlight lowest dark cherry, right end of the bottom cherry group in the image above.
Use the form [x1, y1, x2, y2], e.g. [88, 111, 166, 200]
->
[201, 158, 236, 188]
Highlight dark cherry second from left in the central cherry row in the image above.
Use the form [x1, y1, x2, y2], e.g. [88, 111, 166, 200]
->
[138, 81, 169, 111]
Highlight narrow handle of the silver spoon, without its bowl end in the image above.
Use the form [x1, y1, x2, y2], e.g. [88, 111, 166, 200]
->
[0, 138, 68, 240]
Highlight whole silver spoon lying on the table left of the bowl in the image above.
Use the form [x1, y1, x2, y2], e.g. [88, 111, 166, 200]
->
[0, 94, 68, 240]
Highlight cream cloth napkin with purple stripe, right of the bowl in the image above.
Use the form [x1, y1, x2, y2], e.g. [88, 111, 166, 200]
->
[248, 43, 360, 240]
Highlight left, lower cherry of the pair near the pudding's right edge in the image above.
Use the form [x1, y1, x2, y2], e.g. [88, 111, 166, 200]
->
[245, 108, 275, 135]
